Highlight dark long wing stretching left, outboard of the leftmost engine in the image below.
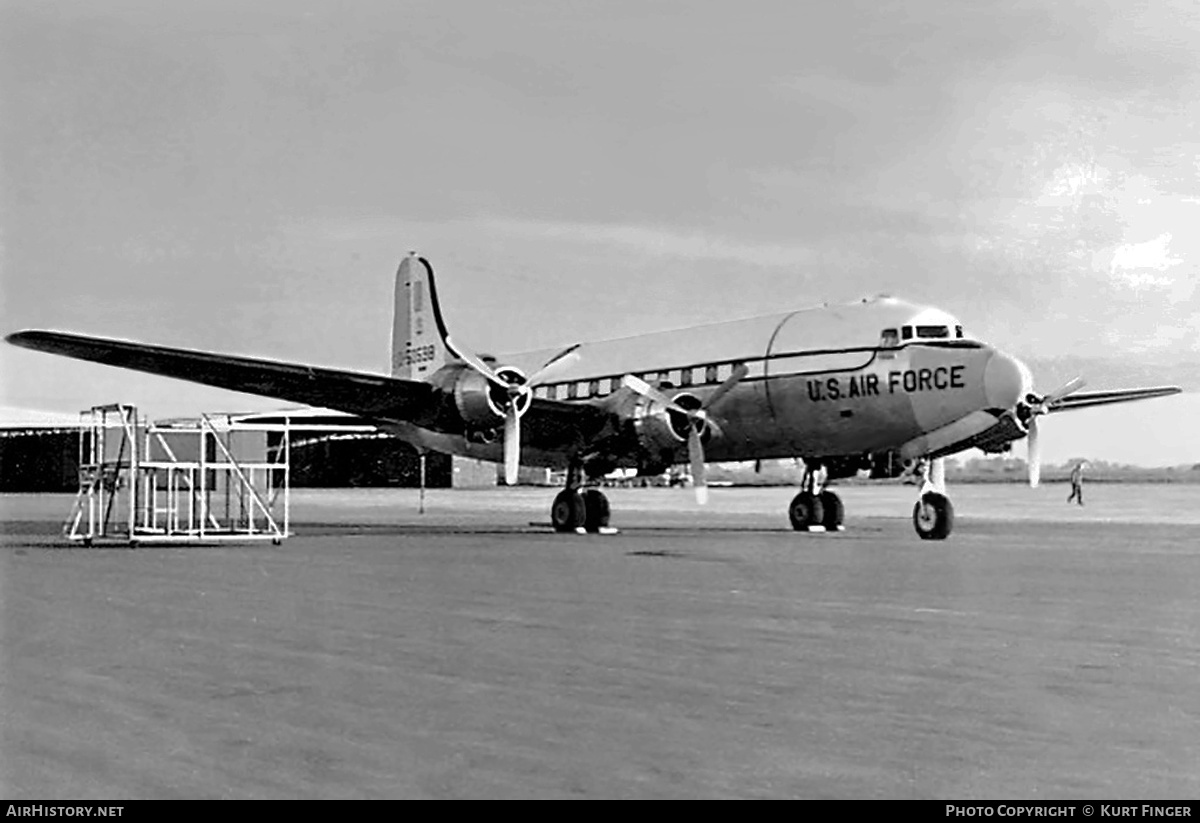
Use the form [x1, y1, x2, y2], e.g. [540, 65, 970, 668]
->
[6, 331, 434, 422]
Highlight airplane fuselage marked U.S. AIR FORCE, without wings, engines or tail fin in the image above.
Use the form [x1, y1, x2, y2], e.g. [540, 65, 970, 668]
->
[397, 298, 1024, 477]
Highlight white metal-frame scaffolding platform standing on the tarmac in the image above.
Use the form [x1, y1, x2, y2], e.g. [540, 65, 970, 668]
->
[62, 403, 290, 546]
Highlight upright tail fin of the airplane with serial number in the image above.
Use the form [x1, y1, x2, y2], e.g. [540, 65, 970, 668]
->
[391, 252, 449, 380]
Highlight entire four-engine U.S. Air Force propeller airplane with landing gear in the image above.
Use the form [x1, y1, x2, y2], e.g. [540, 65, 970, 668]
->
[7, 254, 1180, 540]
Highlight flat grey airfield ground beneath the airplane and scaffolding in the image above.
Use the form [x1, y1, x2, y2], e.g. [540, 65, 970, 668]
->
[0, 485, 1200, 799]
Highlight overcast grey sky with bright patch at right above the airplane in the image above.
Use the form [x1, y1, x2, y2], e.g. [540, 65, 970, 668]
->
[0, 0, 1200, 461]
